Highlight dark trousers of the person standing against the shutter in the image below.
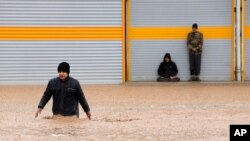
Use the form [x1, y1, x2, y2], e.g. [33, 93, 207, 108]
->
[189, 54, 201, 75]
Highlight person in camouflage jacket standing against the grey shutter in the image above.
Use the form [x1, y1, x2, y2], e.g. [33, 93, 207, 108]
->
[187, 23, 203, 81]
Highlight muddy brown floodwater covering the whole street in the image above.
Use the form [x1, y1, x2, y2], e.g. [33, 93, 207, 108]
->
[0, 82, 250, 141]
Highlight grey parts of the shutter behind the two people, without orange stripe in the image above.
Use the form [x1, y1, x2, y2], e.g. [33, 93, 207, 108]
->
[130, 0, 232, 81]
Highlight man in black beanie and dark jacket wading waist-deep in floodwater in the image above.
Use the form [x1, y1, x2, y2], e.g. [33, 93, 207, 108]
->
[35, 62, 91, 120]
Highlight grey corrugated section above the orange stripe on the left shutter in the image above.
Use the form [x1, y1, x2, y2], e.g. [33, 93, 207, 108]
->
[0, 0, 121, 26]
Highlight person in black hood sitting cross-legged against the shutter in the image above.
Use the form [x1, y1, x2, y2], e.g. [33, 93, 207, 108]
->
[157, 53, 180, 82]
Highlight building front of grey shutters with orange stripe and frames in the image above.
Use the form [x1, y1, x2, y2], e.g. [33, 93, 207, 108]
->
[0, 0, 247, 84]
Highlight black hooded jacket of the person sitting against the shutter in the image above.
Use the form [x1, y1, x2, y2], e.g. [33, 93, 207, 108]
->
[158, 53, 178, 78]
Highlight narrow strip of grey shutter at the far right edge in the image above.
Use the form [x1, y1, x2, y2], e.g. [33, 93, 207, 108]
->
[245, 1, 250, 80]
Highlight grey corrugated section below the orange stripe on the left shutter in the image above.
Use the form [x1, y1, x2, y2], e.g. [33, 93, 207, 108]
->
[0, 41, 122, 84]
